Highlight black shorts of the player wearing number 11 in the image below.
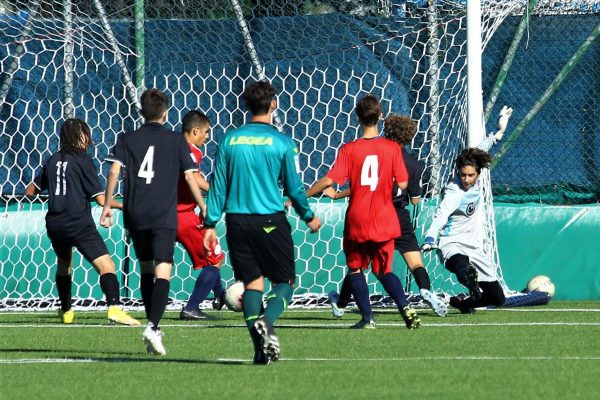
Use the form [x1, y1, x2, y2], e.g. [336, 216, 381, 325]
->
[48, 225, 108, 263]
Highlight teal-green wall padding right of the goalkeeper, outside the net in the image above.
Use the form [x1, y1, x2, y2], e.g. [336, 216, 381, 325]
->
[494, 204, 600, 300]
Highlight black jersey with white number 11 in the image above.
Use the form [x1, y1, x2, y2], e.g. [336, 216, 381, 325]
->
[33, 151, 104, 236]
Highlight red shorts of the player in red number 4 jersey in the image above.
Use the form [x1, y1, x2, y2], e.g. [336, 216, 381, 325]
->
[343, 239, 394, 275]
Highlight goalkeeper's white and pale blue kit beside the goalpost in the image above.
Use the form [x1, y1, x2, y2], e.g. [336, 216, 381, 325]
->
[425, 135, 497, 282]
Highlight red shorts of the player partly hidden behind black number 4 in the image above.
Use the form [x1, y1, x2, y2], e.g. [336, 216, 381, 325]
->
[177, 210, 225, 269]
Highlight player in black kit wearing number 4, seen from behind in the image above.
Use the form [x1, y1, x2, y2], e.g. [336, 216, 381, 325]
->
[100, 89, 204, 355]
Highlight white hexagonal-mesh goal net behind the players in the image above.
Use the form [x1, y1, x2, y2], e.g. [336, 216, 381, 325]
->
[0, 0, 587, 309]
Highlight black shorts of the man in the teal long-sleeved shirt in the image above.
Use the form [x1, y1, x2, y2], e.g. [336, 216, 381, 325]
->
[225, 212, 296, 284]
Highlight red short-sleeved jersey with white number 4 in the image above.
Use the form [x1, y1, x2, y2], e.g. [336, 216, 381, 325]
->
[327, 137, 408, 242]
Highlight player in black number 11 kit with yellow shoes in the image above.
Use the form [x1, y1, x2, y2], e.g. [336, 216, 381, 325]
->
[25, 118, 140, 325]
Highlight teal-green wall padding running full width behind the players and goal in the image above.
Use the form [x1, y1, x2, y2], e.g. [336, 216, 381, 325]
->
[0, 200, 600, 300]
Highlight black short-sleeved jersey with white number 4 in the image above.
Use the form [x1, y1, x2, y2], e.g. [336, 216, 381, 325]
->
[106, 122, 198, 229]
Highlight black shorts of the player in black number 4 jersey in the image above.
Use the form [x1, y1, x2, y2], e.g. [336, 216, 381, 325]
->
[129, 229, 177, 263]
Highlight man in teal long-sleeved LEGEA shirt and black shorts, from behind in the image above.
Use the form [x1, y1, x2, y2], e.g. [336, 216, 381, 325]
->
[204, 82, 321, 364]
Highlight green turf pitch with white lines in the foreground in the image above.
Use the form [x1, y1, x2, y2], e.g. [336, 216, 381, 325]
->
[0, 302, 600, 400]
